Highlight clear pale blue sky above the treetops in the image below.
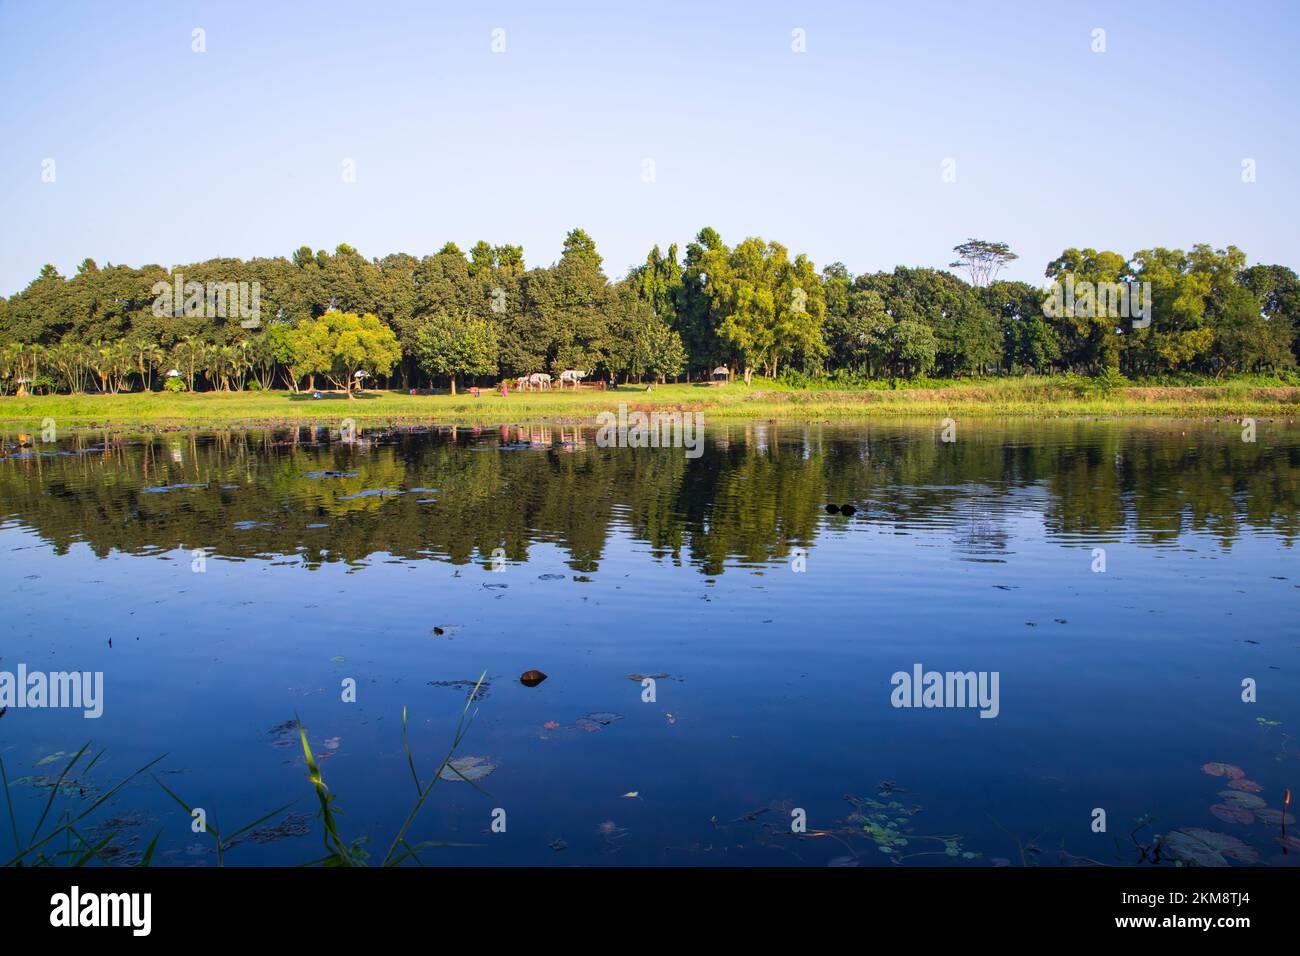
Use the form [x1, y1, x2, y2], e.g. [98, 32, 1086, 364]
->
[0, 0, 1300, 295]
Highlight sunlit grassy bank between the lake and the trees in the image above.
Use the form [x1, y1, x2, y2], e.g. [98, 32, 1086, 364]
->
[0, 377, 1300, 431]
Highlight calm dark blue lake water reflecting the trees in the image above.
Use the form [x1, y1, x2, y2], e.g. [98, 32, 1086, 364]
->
[0, 423, 1300, 866]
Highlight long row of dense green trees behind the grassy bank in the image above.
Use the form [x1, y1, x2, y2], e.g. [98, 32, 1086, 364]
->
[0, 228, 1300, 393]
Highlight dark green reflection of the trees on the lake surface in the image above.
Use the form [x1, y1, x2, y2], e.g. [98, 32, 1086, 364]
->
[0, 423, 1300, 575]
